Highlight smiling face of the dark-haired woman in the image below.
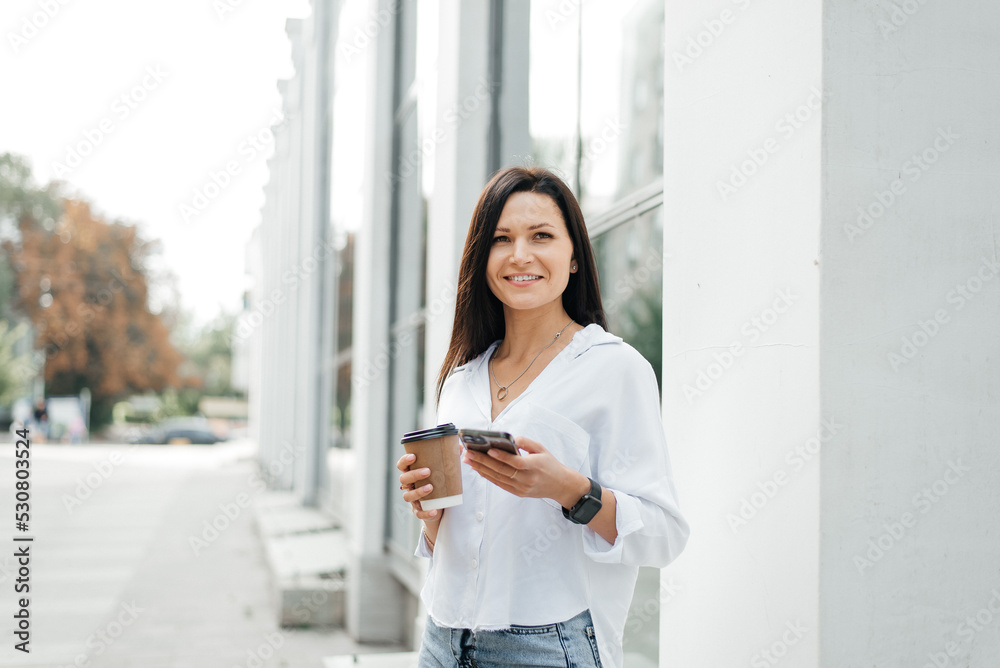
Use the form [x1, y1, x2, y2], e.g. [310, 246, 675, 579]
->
[486, 192, 575, 309]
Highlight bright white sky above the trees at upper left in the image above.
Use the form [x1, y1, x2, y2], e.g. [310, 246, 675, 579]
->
[0, 0, 309, 322]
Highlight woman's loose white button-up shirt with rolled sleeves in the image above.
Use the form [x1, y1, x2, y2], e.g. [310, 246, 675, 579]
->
[416, 324, 688, 667]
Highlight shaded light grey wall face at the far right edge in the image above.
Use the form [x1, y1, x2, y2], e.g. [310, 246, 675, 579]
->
[820, 0, 1000, 667]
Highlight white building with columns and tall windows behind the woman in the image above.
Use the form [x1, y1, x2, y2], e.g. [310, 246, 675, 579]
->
[248, 0, 1000, 666]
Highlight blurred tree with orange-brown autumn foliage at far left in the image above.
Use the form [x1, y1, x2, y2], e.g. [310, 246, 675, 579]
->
[5, 155, 185, 425]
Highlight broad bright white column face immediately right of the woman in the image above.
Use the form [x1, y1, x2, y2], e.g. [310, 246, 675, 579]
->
[660, 0, 820, 667]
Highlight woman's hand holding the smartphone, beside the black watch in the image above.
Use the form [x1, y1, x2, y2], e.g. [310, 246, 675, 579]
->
[462, 436, 590, 507]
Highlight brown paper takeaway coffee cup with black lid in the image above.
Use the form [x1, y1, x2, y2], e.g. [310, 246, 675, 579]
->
[401, 422, 462, 510]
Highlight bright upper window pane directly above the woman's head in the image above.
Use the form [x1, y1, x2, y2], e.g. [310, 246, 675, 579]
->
[529, 0, 664, 217]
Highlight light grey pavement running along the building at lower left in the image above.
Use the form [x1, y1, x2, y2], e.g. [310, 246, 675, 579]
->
[0, 442, 398, 668]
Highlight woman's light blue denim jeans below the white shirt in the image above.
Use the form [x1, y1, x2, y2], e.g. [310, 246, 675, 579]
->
[417, 610, 601, 668]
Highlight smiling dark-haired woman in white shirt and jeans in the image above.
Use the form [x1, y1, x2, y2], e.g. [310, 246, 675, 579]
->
[396, 168, 688, 668]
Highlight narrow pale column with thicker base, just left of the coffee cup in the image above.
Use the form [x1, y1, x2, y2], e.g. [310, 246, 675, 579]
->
[346, 0, 403, 642]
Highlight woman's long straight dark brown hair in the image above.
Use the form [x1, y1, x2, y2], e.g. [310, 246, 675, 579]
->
[437, 167, 608, 403]
